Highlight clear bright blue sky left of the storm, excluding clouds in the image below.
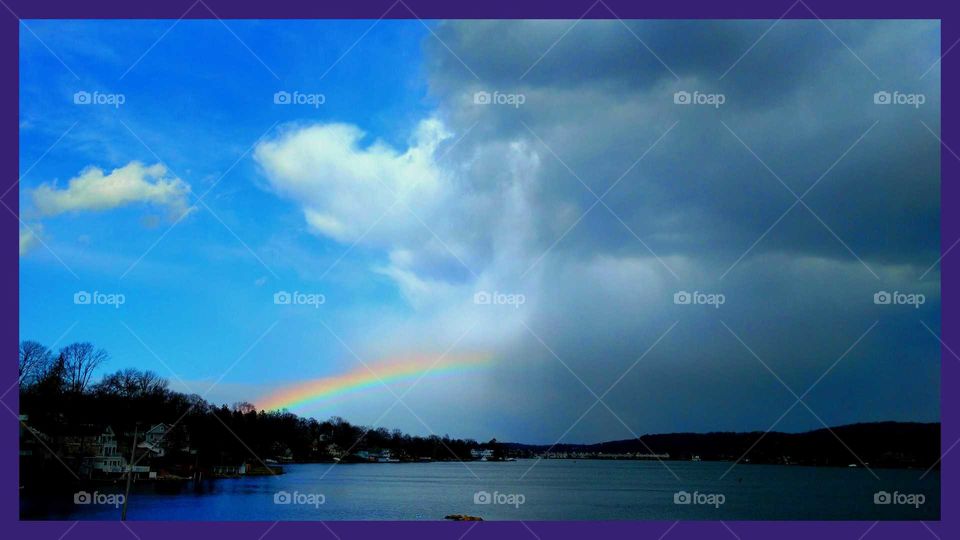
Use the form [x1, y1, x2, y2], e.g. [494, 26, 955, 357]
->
[20, 21, 430, 414]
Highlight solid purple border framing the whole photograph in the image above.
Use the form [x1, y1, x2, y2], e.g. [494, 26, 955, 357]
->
[0, 0, 960, 540]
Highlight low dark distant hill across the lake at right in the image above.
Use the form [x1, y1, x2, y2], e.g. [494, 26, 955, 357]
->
[503, 422, 940, 468]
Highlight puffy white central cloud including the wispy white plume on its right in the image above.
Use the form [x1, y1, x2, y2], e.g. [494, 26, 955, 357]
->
[254, 118, 539, 304]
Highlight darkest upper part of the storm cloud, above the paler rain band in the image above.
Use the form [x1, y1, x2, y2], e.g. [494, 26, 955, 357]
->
[428, 21, 939, 273]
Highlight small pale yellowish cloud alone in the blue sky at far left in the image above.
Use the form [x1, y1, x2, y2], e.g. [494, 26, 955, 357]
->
[31, 161, 190, 219]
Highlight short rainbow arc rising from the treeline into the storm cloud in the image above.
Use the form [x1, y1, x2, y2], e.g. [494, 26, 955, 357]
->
[257, 354, 493, 411]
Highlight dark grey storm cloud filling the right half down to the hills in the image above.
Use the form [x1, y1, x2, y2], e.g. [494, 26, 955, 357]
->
[416, 21, 940, 442]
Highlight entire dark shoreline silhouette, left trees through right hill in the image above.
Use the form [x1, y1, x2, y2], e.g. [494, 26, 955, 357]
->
[20, 341, 940, 488]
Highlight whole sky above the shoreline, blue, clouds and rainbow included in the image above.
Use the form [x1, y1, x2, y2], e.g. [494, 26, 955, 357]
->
[18, 20, 941, 444]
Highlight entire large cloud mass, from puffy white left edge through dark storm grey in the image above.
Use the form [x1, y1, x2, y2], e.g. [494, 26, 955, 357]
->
[255, 21, 940, 442]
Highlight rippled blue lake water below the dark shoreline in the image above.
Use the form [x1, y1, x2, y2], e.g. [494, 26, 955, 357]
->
[21, 460, 940, 521]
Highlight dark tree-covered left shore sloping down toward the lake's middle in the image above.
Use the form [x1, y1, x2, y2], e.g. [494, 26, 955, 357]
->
[20, 341, 500, 490]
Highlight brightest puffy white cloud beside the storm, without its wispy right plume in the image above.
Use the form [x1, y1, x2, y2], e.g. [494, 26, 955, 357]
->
[254, 120, 449, 243]
